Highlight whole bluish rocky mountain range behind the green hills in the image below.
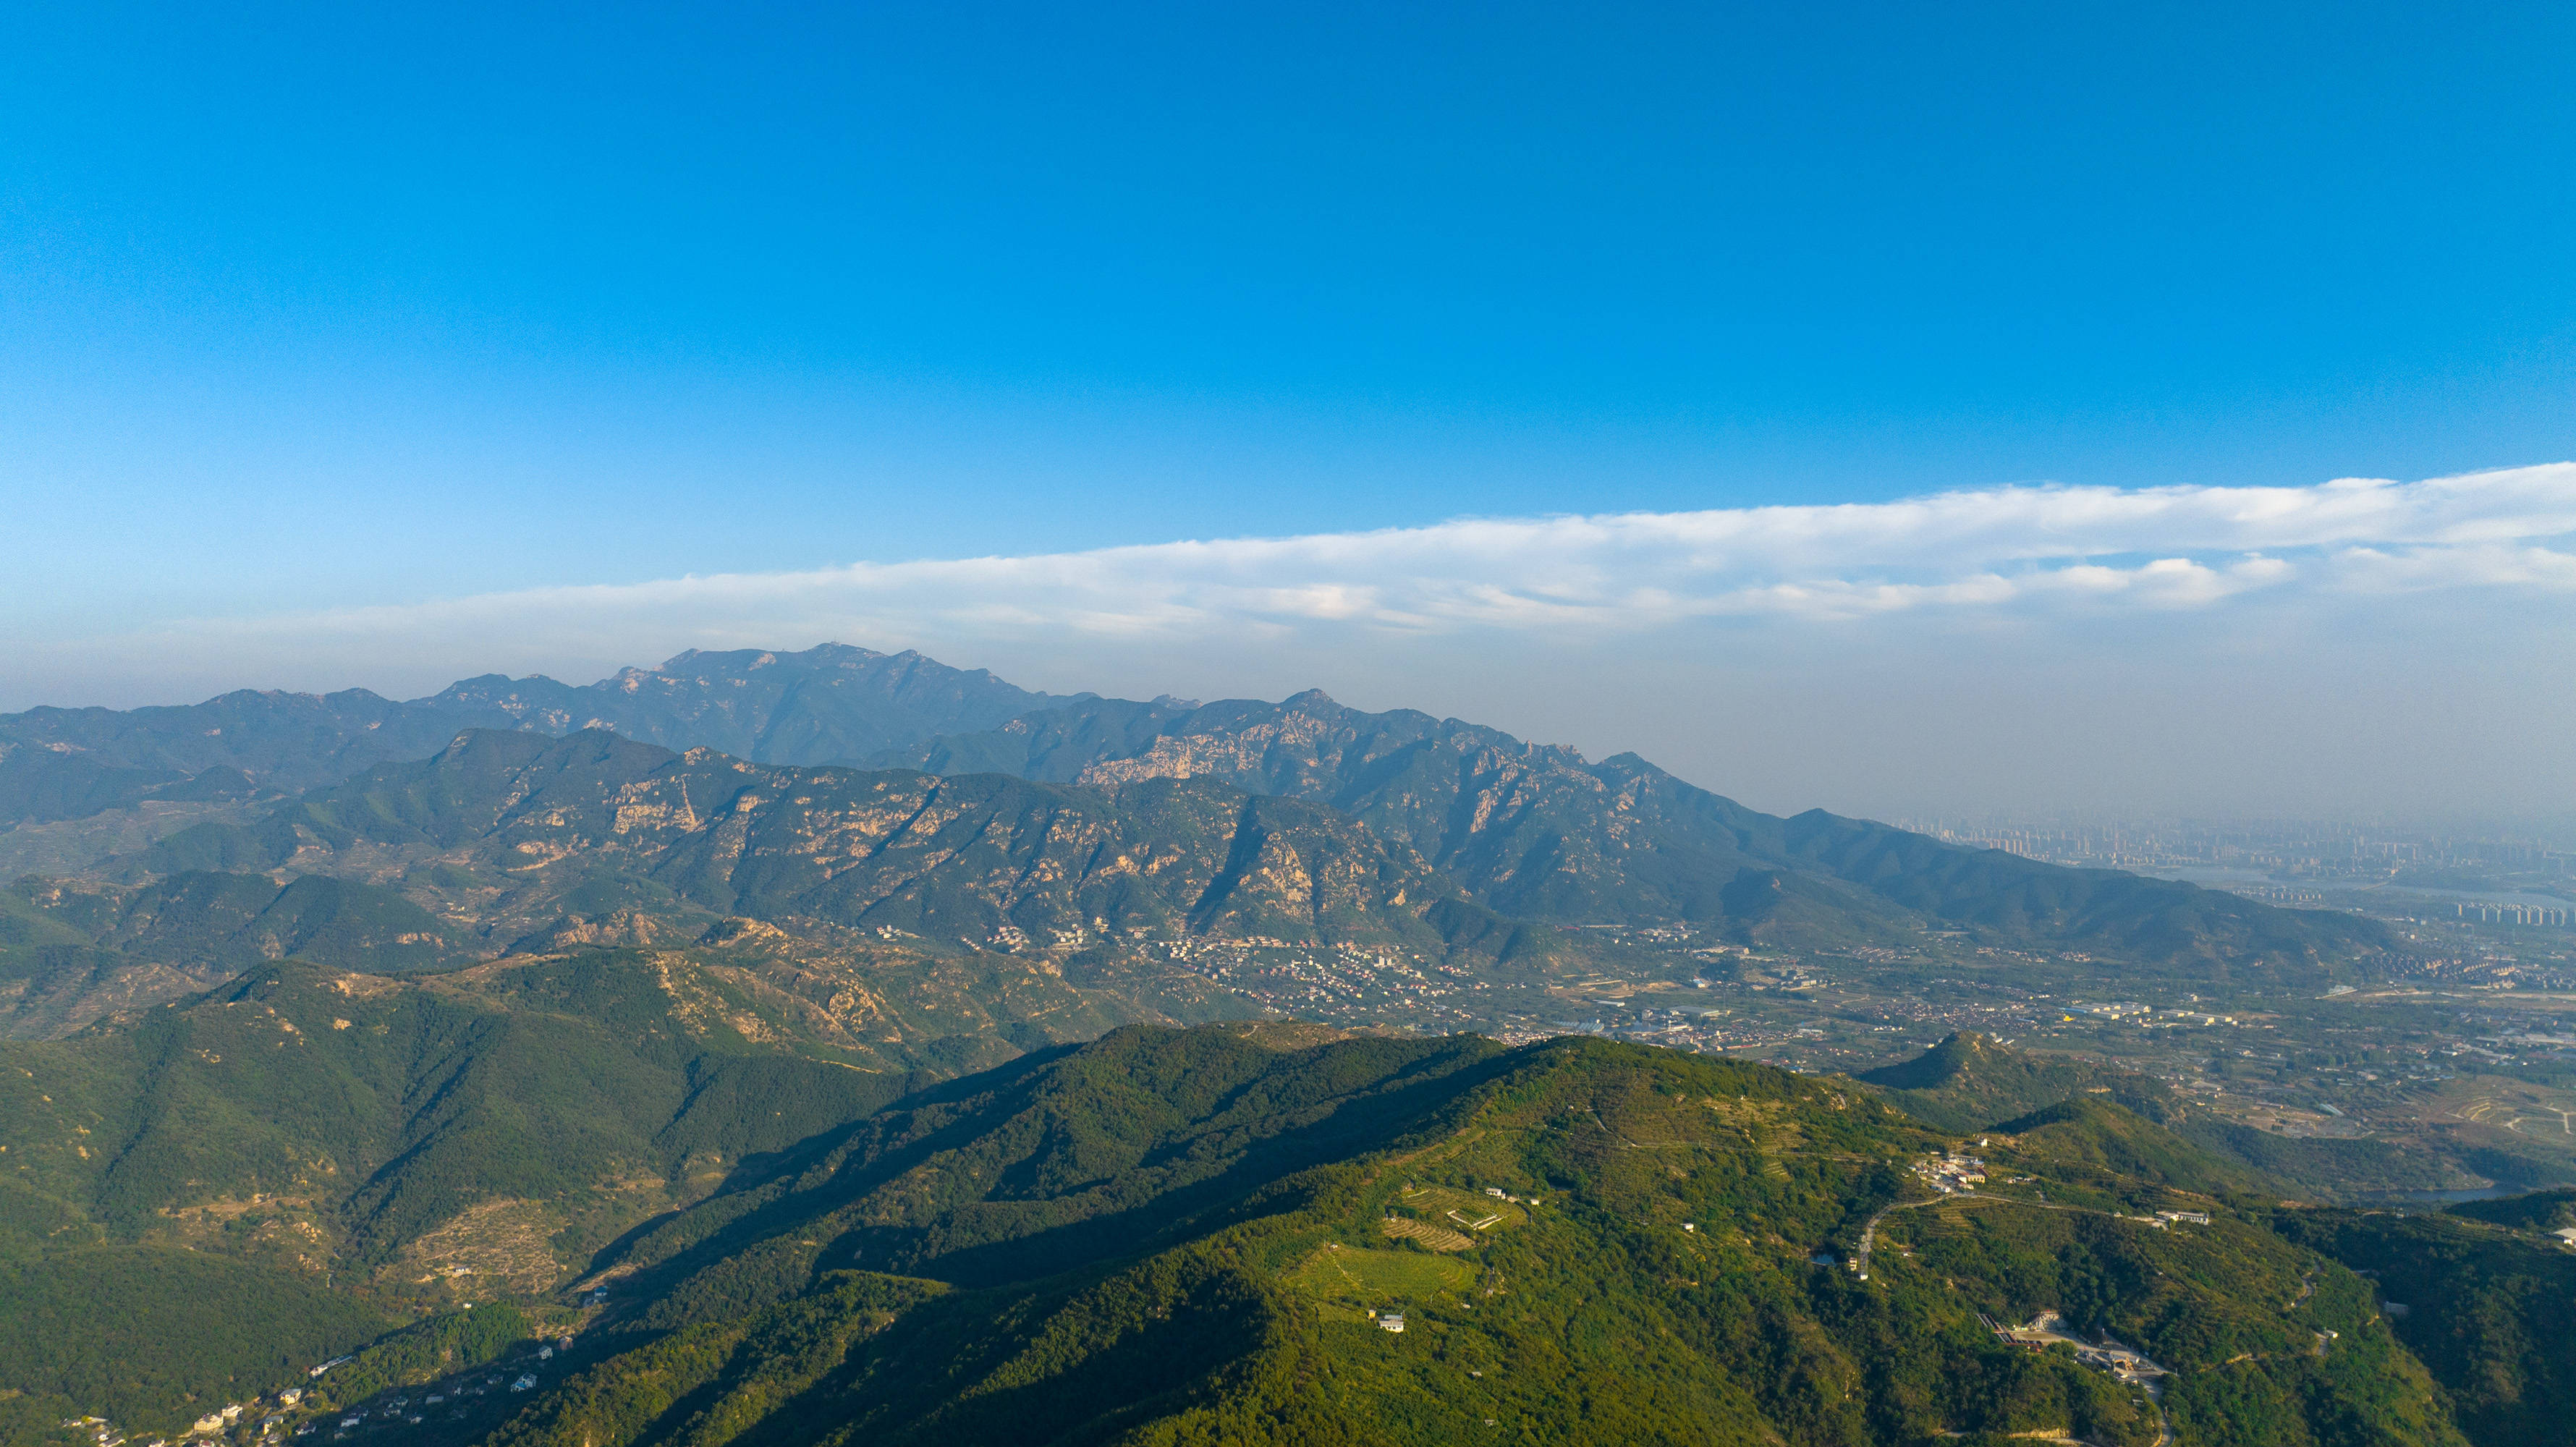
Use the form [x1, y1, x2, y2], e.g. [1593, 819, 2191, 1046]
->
[0, 646, 2386, 1032]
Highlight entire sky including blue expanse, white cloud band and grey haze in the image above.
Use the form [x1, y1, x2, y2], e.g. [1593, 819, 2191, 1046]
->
[0, 8, 2576, 819]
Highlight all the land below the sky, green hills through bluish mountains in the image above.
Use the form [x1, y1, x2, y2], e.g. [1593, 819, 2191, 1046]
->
[0, 649, 2576, 1447]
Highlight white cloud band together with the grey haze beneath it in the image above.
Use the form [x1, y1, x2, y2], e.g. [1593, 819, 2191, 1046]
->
[0, 464, 2576, 819]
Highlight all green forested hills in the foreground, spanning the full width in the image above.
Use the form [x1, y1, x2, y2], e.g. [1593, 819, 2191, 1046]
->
[0, 988, 2558, 1447]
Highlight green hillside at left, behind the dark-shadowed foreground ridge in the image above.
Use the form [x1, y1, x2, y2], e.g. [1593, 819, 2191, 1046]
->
[0, 930, 1252, 1439]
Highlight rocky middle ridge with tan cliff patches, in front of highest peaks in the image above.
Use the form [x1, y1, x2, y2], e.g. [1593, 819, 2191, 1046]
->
[140, 731, 1507, 950]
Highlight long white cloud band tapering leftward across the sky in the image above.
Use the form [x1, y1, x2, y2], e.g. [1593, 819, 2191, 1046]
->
[9, 464, 2576, 703]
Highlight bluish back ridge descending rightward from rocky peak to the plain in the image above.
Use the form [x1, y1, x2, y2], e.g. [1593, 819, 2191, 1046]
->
[876, 692, 2383, 976]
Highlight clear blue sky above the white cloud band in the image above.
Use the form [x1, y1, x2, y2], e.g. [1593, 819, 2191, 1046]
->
[0, 5, 2576, 813]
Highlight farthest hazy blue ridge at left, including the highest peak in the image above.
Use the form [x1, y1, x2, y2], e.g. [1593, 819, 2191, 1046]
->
[0, 644, 1064, 826]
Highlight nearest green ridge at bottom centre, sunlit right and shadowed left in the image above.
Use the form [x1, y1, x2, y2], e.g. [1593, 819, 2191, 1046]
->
[474, 1027, 2457, 1447]
